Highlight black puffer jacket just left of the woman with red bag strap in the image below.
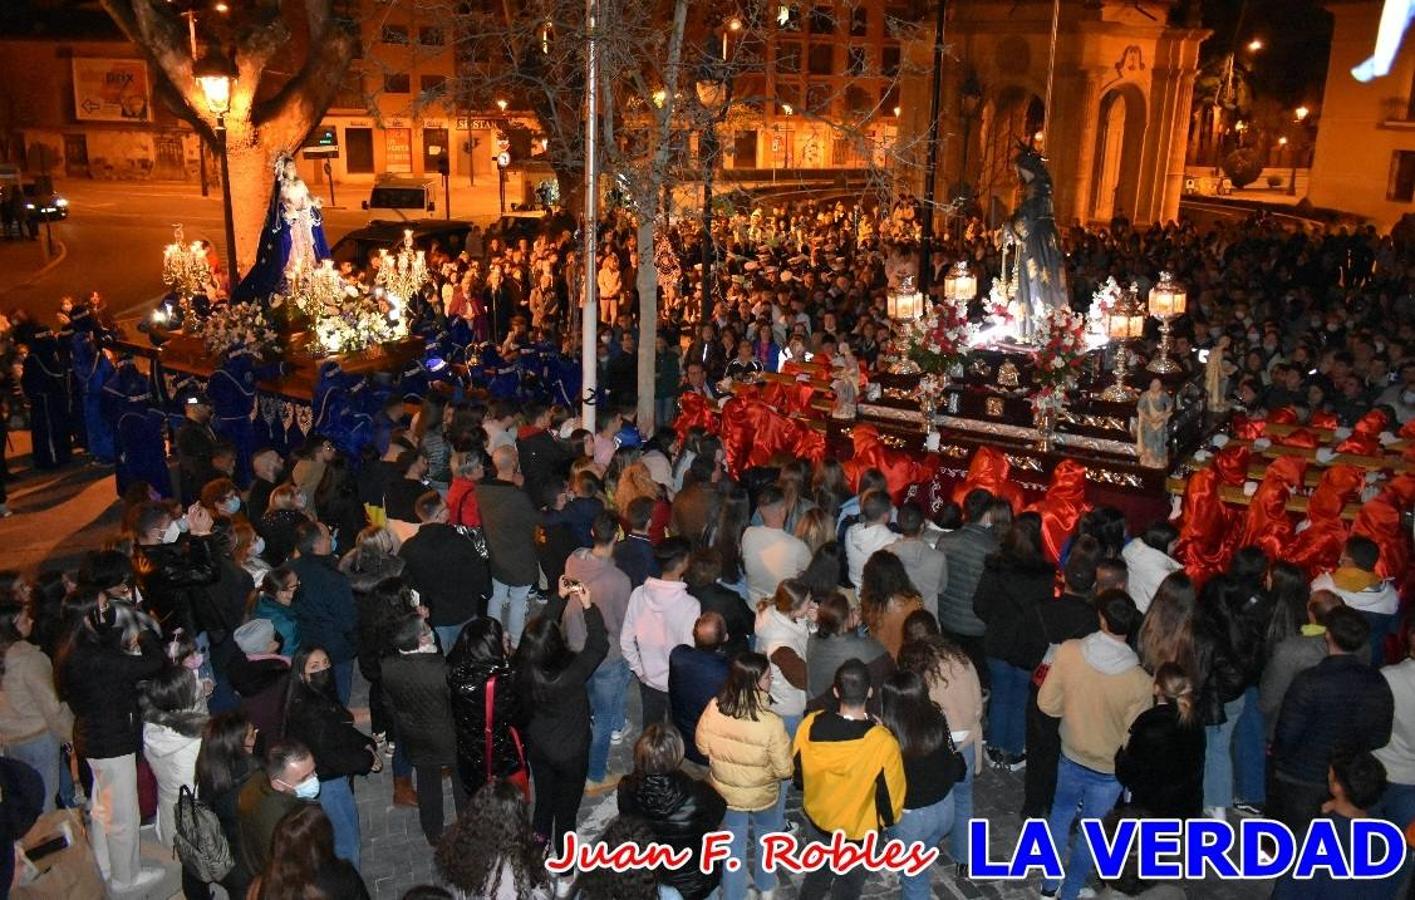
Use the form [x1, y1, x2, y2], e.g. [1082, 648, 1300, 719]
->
[383, 652, 457, 766]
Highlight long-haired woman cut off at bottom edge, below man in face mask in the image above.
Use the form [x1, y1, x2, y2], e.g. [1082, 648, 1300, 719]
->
[250, 804, 368, 900]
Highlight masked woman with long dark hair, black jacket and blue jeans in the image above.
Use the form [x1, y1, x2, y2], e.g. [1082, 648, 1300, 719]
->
[283, 647, 383, 869]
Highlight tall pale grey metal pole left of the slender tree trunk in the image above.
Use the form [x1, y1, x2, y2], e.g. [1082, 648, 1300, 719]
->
[580, 0, 600, 432]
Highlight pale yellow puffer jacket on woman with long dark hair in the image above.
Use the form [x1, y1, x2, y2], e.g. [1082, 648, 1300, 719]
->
[696, 696, 791, 812]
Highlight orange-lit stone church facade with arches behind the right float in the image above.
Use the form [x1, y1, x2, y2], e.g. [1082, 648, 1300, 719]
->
[896, 0, 1208, 225]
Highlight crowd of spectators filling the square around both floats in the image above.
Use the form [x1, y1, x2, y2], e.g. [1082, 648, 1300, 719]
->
[0, 204, 1415, 900]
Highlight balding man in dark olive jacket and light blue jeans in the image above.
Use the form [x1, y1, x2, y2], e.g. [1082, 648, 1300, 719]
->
[477, 444, 541, 644]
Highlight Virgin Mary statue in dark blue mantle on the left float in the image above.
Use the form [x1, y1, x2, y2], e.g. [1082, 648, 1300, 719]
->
[232, 153, 330, 301]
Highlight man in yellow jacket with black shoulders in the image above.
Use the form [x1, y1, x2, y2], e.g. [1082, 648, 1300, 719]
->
[791, 659, 904, 900]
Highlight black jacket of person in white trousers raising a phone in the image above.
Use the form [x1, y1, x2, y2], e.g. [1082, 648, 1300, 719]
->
[59, 624, 167, 760]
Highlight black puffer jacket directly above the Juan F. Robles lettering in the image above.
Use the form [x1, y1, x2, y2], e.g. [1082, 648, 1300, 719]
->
[618, 771, 727, 900]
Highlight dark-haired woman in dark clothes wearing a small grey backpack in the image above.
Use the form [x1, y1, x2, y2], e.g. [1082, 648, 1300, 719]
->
[192, 712, 260, 900]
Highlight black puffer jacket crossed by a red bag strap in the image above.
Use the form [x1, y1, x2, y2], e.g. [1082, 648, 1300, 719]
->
[447, 659, 522, 792]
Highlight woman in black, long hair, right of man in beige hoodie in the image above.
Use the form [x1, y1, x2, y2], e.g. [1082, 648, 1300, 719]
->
[1115, 662, 1204, 819]
